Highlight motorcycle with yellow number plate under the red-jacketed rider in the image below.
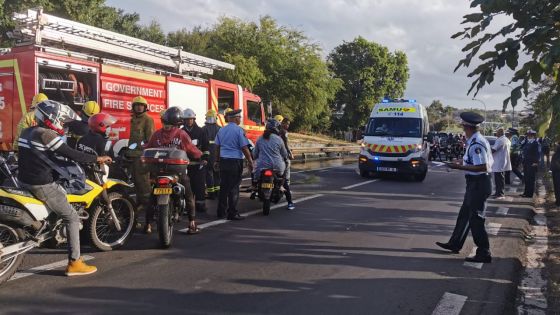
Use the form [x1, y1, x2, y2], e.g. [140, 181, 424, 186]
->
[142, 148, 189, 248]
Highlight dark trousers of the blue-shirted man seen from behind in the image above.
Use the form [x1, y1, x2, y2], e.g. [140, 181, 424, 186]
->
[217, 158, 243, 217]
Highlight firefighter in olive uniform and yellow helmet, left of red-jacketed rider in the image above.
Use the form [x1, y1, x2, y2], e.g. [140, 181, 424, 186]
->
[126, 96, 154, 234]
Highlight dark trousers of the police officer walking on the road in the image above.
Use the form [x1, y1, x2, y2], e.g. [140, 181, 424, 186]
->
[449, 175, 492, 256]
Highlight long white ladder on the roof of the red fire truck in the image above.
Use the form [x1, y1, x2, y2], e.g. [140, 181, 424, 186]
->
[12, 8, 235, 74]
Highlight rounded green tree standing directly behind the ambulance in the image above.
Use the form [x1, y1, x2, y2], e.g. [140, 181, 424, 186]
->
[328, 37, 409, 130]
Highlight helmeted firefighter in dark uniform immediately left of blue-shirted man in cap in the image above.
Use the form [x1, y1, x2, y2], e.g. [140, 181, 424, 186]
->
[202, 109, 220, 200]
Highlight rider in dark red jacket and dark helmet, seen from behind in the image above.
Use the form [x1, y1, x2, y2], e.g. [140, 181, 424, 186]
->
[146, 107, 202, 234]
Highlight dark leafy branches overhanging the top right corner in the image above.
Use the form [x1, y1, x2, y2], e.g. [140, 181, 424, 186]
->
[452, 0, 560, 110]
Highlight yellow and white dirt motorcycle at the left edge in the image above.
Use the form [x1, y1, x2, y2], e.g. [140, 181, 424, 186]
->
[0, 157, 135, 284]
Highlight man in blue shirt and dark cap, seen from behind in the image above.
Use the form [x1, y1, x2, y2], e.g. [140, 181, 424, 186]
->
[214, 109, 253, 221]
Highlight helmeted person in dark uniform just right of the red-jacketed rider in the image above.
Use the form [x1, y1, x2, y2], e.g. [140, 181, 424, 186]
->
[183, 108, 210, 212]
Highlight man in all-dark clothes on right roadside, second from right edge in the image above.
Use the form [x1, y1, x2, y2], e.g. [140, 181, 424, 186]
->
[521, 130, 540, 198]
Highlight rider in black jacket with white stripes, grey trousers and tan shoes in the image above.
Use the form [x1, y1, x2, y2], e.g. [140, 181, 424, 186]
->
[18, 100, 111, 276]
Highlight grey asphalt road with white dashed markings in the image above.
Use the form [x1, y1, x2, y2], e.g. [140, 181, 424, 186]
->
[0, 163, 530, 314]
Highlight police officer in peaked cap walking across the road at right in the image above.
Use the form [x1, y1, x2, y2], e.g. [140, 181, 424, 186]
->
[436, 112, 493, 263]
